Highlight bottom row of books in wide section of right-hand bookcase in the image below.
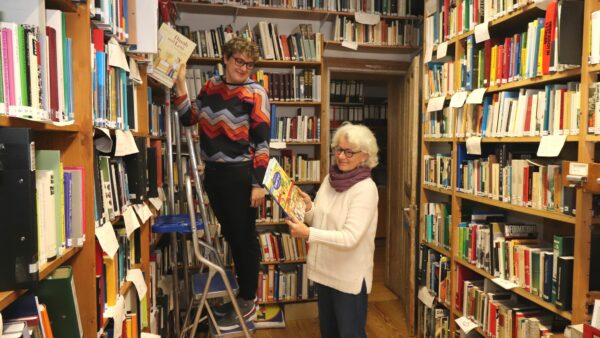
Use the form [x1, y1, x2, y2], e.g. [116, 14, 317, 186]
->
[457, 274, 571, 338]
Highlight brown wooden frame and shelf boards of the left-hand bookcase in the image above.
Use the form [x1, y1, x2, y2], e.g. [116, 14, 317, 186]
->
[0, 0, 157, 337]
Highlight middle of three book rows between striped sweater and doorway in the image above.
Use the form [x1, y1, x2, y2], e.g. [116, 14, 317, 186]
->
[271, 104, 321, 142]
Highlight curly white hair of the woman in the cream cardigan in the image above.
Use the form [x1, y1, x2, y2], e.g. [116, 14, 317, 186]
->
[331, 122, 379, 169]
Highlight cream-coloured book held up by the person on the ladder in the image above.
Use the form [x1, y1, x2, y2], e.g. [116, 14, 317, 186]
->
[148, 23, 196, 88]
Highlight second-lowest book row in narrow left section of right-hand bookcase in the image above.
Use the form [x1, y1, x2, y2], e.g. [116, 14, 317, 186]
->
[417, 244, 452, 306]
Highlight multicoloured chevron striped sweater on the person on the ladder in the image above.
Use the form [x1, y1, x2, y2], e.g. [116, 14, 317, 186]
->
[174, 76, 271, 186]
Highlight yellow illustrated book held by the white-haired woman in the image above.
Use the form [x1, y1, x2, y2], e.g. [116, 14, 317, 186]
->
[263, 158, 306, 222]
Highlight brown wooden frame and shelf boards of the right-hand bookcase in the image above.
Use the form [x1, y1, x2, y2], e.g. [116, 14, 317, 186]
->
[419, 1, 600, 337]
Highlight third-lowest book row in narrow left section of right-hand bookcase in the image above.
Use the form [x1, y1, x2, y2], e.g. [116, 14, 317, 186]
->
[422, 202, 452, 250]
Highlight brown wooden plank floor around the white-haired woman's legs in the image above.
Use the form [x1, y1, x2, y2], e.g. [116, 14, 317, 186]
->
[254, 241, 408, 338]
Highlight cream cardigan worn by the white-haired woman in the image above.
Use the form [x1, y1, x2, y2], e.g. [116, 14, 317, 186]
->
[305, 175, 379, 294]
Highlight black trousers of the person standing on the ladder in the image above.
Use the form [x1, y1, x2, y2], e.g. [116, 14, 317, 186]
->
[204, 162, 260, 300]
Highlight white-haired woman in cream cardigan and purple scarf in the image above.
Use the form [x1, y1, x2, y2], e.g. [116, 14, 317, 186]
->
[287, 123, 379, 338]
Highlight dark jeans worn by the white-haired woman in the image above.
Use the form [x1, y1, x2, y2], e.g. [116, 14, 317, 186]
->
[315, 280, 367, 338]
